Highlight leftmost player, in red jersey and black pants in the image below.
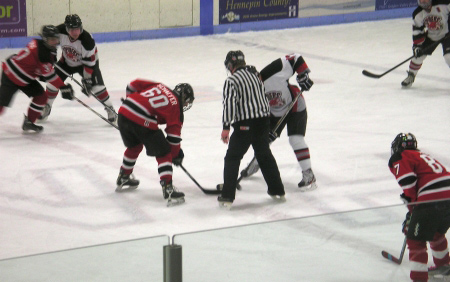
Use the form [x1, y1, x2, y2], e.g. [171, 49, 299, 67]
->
[0, 25, 73, 132]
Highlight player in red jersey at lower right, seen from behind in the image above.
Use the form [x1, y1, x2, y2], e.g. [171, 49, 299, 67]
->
[389, 133, 450, 281]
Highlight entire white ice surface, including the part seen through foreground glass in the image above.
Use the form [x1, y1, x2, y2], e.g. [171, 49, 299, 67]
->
[0, 18, 450, 281]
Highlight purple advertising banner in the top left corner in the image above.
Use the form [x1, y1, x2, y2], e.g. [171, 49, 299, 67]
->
[0, 0, 27, 38]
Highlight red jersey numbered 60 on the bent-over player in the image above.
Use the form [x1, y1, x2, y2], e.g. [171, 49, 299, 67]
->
[119, 79, 183, 157]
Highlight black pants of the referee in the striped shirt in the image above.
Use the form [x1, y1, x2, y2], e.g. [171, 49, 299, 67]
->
[222, 117, 284, 201]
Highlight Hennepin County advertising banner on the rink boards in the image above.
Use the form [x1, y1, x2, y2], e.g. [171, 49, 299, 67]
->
[219, 0, 298, 24]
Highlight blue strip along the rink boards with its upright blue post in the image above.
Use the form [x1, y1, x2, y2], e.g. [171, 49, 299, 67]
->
[0, 7, 414, 48]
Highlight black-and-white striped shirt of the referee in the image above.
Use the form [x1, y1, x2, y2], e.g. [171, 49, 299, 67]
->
[222, 66, 270, 129]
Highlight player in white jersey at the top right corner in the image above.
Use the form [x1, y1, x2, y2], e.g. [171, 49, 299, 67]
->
[402, 0, 450, 87]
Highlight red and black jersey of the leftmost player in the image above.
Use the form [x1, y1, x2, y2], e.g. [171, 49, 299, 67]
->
[2, 39, 64, 88]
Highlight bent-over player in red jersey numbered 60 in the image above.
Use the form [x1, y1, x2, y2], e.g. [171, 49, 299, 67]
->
[116, 79, 195, 206]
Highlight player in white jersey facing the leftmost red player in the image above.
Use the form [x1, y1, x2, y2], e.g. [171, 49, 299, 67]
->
[41, 14, 117, 122]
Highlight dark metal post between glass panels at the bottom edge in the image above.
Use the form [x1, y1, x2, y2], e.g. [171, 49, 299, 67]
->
[164, 244, 183, 282]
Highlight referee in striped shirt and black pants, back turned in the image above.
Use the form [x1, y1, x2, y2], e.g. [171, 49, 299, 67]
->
[218, 51, 285, 208]
